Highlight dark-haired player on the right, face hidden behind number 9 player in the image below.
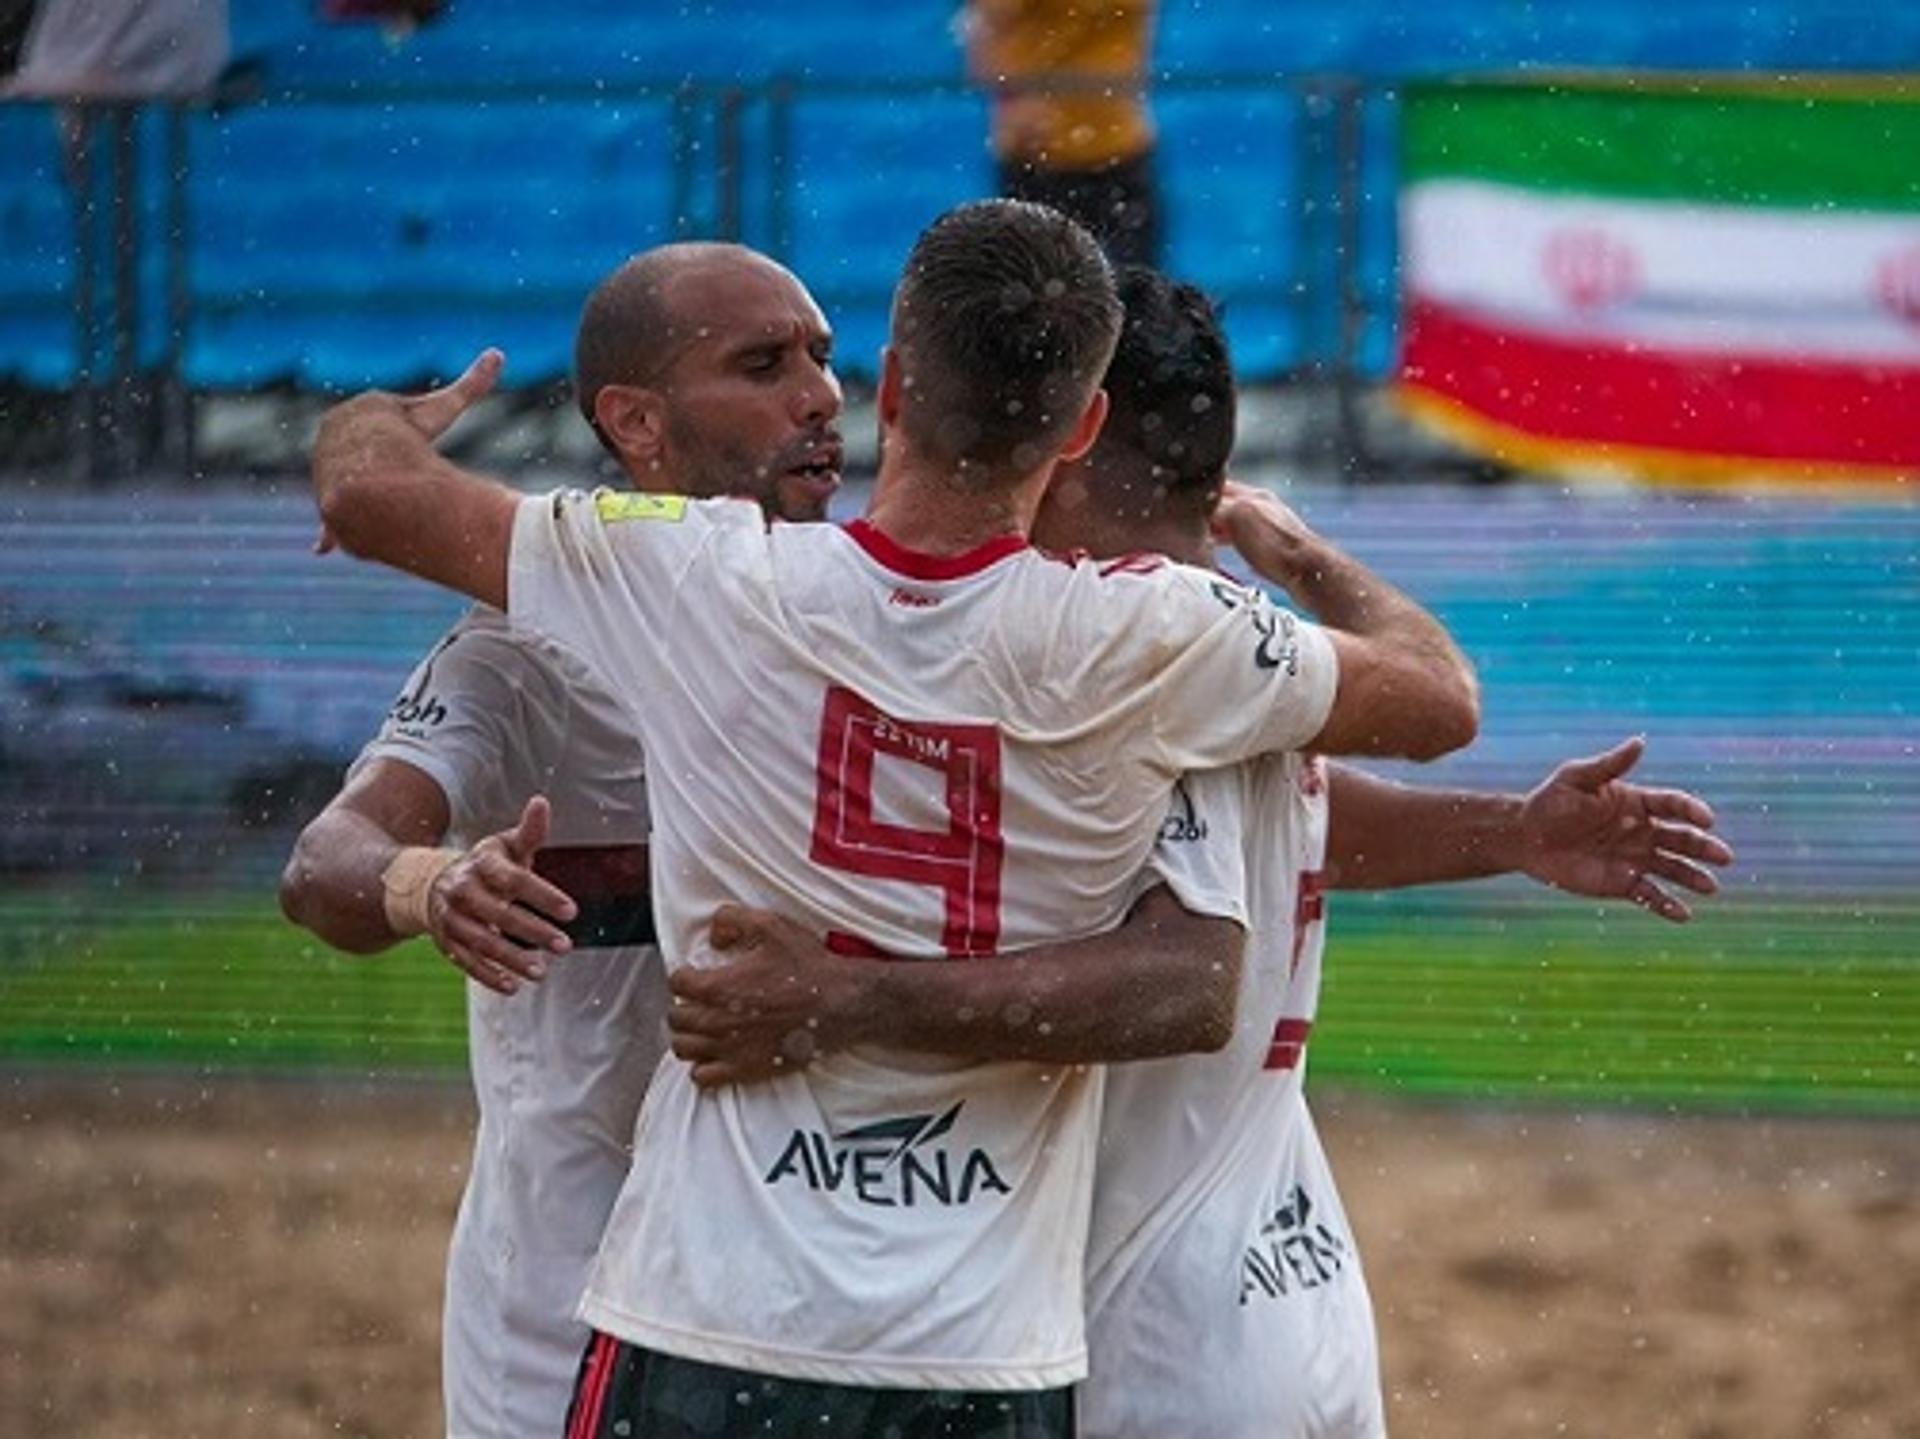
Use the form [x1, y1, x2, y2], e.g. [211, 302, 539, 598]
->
[670, 269, 1730, 1439]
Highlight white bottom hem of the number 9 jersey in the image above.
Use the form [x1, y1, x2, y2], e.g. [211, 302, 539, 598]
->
[580, 1297, 1087, 1393]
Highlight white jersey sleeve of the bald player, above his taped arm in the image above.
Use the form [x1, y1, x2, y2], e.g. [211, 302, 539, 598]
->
[348, 624, 570, 840]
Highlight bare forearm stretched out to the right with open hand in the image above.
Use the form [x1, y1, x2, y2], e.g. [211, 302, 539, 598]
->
[1327, 738, 1734, 924]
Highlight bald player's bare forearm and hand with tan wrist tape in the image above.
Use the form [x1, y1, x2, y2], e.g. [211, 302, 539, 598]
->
[280, 759, 574, 993]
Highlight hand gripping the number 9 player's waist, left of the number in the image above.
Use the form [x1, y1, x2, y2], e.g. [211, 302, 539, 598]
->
[666, 905, 874, 1087]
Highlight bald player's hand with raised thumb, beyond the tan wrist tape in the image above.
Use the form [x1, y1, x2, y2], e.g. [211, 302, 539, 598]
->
[426, 795, 576, 995]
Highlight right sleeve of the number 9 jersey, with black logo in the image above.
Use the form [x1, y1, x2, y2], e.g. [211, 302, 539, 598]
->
[1154, 567, 1338, 770]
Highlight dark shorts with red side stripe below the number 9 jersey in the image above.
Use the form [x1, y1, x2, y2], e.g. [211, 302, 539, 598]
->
[566, 1333, 1073, 1439]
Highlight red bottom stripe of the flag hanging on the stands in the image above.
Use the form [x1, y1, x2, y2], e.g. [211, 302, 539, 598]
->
[1400, 300, 1920, 467]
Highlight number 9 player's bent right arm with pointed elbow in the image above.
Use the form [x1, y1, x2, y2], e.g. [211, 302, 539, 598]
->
[1213, 480, 1480, 759]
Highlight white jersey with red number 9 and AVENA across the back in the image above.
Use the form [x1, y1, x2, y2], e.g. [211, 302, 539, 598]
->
[511, 494, 1334, 1389]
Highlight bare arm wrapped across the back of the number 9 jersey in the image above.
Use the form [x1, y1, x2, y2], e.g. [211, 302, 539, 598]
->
[668, 886, 1246, 1085]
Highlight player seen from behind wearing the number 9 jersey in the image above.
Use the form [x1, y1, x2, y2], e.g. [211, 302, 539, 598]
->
[313, 202, 1478, 1435]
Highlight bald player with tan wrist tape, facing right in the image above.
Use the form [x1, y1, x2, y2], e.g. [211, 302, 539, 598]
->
[280, 244, 841, 1439]
